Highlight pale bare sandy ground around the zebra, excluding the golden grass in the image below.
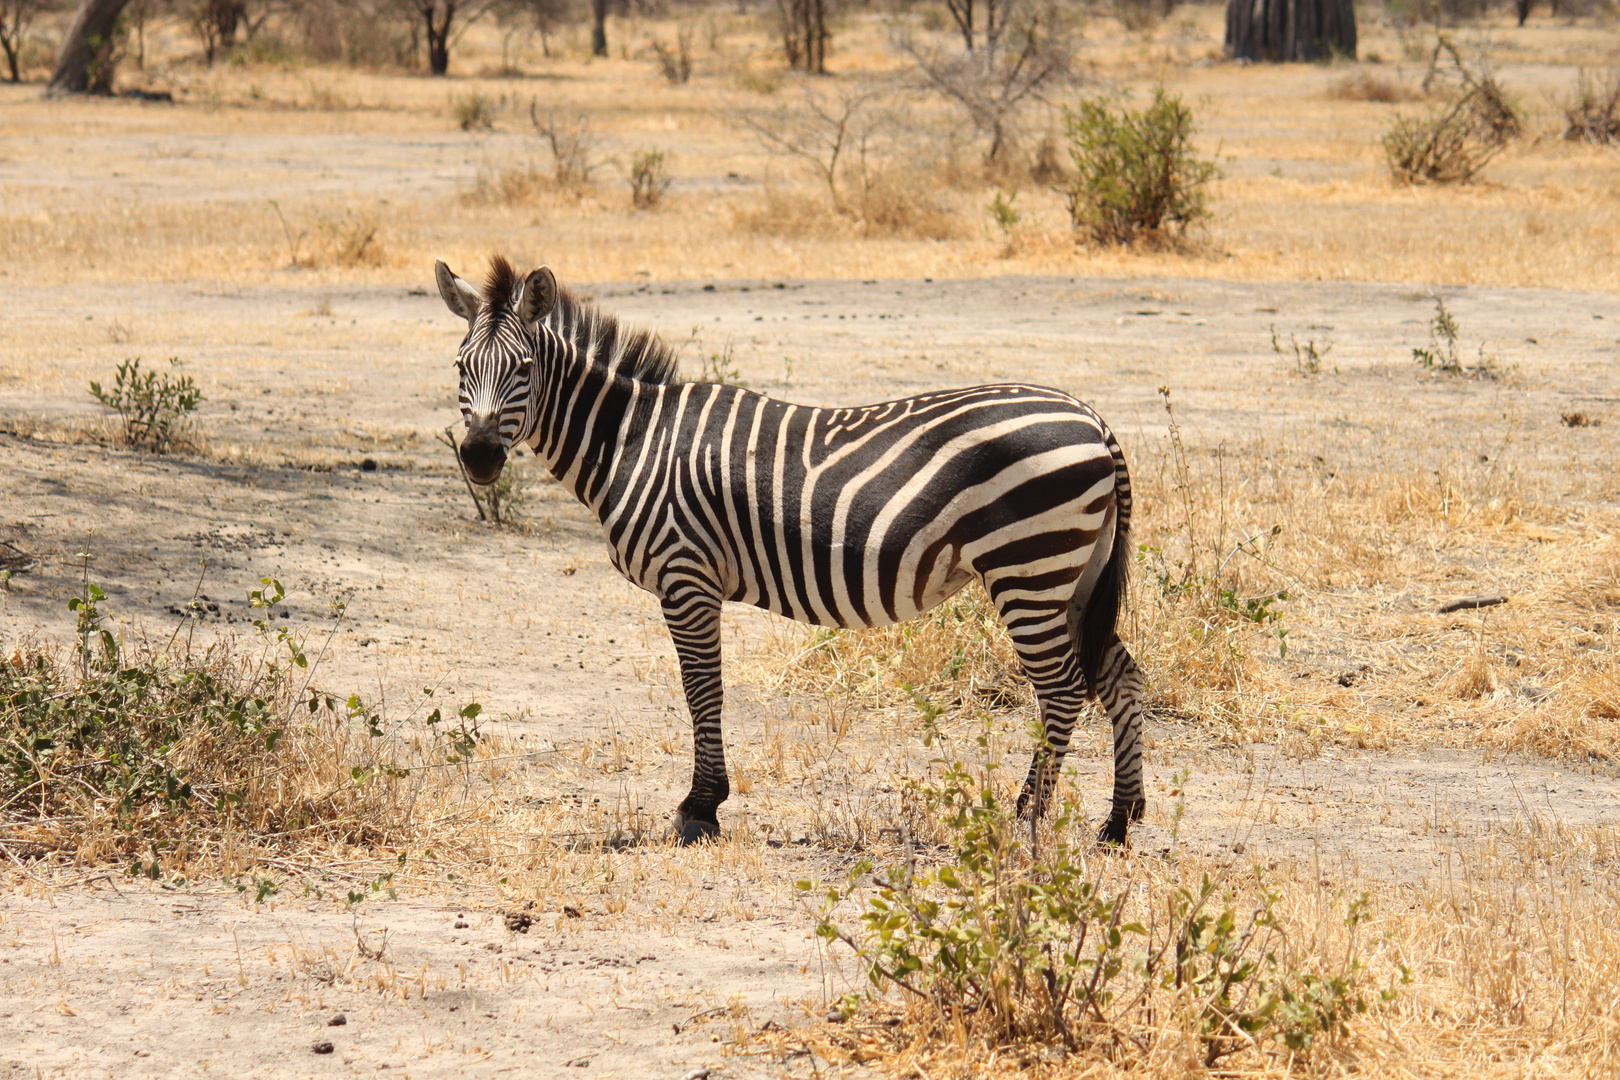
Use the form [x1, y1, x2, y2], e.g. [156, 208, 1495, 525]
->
[0, 275, 1620, 1078]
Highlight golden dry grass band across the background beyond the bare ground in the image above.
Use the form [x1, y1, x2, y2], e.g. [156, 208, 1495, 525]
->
[0, 8, 1617, 288]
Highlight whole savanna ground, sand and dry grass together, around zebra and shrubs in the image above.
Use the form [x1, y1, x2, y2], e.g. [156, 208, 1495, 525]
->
[0, 8, 1620, 1078]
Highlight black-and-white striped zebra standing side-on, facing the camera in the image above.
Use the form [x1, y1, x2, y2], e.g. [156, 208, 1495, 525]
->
[434, 256, 1145, 844]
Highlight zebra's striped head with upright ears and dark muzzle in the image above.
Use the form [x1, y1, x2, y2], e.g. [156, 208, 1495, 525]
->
[434, 256, 557, 484]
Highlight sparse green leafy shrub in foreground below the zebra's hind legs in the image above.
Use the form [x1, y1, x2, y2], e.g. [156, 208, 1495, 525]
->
[799, 763, 1369, 1067]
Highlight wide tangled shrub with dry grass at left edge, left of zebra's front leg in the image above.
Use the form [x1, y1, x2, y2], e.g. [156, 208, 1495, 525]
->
[0, 576, 481, 878]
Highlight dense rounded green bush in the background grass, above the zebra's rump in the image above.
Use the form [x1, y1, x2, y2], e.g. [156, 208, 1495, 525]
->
[1061, 87, 1220, 244]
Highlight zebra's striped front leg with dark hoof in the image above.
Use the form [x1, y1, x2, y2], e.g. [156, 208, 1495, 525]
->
[663, 581, 731, 844]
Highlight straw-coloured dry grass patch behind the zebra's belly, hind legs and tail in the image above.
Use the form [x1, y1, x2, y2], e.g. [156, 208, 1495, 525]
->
[757, 417, 1620, 766]
